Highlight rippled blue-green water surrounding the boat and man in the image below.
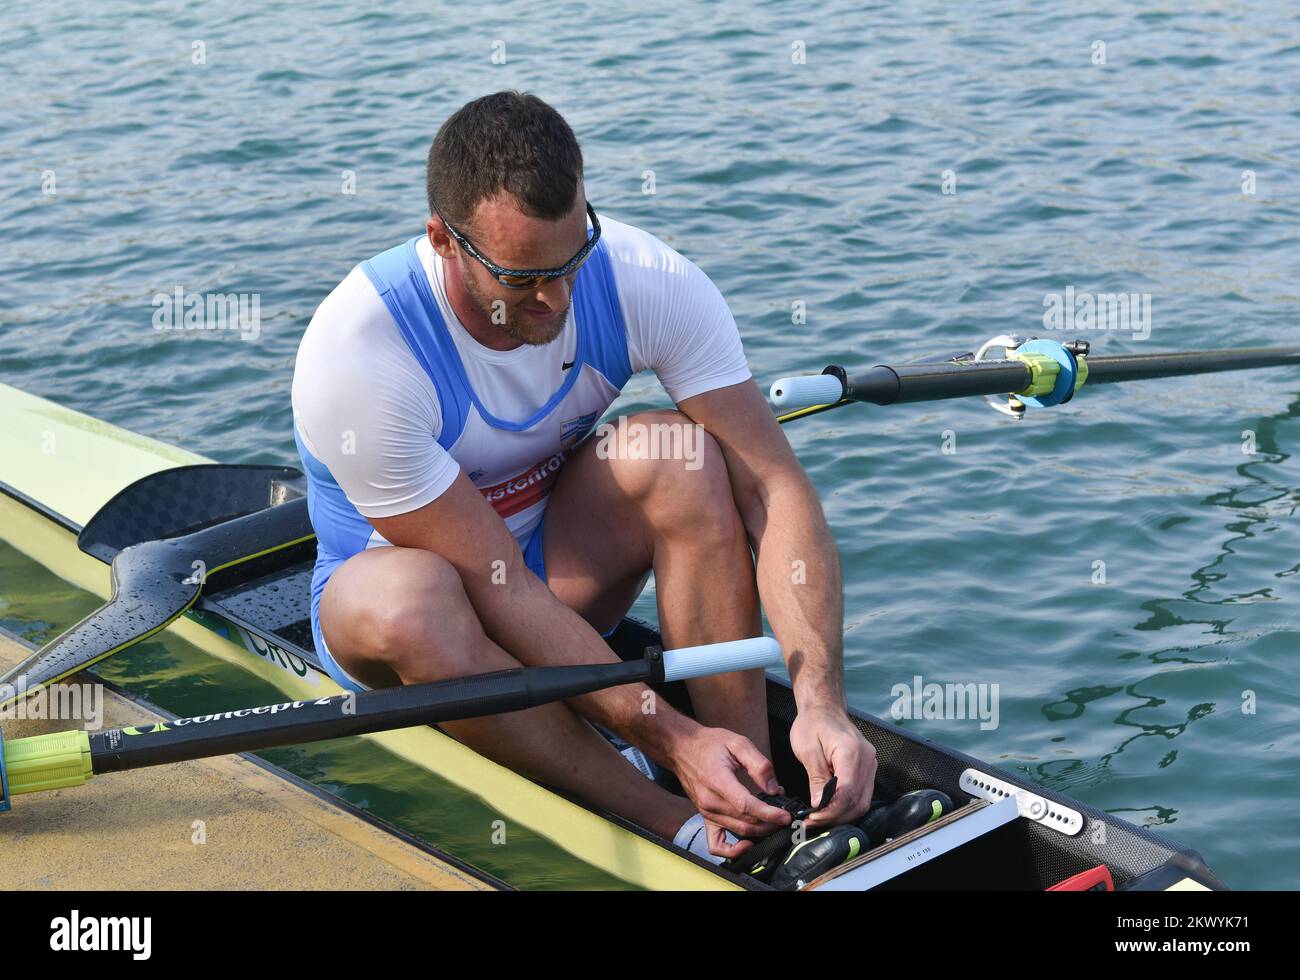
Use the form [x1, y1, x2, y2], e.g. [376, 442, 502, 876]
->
[0, 0, 1300, 888]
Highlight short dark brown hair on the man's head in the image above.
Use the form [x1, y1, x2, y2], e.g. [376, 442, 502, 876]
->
[426, 91, 582, 229]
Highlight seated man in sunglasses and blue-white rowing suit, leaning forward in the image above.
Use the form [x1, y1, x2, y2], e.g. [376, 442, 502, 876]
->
[293, 92, 875, 859]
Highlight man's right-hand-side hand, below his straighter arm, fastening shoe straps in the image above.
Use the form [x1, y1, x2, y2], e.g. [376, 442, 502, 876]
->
[790, 704, 876, 828]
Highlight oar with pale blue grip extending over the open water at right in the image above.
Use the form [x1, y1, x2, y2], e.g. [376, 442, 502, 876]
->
[770, 337, 1300, 422]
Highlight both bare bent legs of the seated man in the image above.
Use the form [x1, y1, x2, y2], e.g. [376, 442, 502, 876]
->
[320, 412, 771, 837]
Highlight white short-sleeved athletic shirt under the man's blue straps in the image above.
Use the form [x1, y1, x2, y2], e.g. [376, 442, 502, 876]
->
[293, 216, 750, 547]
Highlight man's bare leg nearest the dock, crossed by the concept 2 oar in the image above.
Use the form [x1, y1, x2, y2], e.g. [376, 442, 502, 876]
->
[320, 547, 694, 838]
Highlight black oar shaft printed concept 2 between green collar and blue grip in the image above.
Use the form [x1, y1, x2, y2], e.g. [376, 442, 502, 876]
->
[90, 658, 663, 773]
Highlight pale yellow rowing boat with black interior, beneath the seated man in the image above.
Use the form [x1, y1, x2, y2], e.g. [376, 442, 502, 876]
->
[0, 376, 1223, 890]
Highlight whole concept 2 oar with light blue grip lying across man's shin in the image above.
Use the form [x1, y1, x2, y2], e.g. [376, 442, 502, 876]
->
[0, 637, 781, 810]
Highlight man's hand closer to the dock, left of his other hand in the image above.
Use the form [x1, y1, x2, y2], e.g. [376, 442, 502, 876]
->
[672, 728, 790, 858]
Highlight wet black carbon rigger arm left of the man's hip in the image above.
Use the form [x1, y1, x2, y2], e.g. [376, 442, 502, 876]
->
[0, 498, 315, 707]
